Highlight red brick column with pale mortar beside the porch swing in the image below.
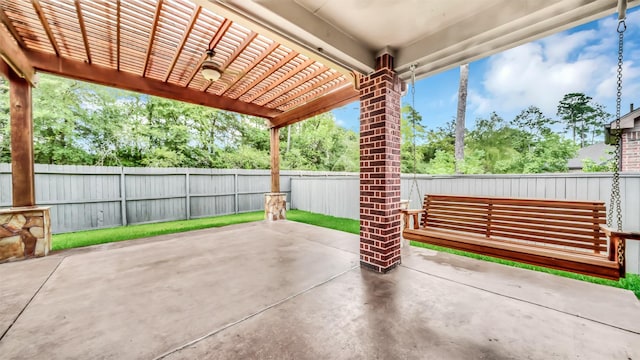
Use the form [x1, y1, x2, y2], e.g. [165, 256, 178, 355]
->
[360, 54, 402, 273]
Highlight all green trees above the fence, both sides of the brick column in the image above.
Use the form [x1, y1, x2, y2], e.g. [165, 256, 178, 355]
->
[0, 75, 609, 174]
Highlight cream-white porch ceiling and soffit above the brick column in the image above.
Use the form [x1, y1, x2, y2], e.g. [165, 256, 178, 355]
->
[209, 0, 640, 79]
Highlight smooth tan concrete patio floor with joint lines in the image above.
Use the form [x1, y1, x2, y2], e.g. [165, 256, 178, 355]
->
[0, 221, 640, 359]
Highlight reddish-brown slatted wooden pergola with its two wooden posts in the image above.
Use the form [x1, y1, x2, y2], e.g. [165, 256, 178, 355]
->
[0, 0, 358, 207]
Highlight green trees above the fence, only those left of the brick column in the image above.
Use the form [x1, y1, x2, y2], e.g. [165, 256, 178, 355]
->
[0, 74, 359, 171]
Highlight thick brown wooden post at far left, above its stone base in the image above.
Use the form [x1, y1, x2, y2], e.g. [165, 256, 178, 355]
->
[8, 69, 36, 207]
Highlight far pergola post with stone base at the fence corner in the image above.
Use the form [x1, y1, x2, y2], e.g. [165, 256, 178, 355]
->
[264, 126, 287, 221]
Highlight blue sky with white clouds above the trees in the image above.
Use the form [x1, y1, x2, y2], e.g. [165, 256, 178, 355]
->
[333, 8, 640, 131]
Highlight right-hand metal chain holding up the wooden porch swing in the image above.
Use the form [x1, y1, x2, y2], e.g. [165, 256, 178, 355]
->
[607, 15, 627, 266]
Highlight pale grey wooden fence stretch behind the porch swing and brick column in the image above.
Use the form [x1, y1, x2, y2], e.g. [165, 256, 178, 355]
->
[291, 173, 640, 274]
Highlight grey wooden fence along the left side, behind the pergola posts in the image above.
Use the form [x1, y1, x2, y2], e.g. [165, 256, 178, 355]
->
[0, 164, 350, 233]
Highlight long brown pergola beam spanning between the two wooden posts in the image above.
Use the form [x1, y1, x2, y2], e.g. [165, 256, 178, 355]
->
[26, 51, 281, 119]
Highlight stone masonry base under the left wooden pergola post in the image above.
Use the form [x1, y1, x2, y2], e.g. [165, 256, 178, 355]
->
[0, 207, 51, 262]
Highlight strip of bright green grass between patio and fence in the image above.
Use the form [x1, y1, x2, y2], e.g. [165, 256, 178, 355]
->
[52, 210, 640, 299]
